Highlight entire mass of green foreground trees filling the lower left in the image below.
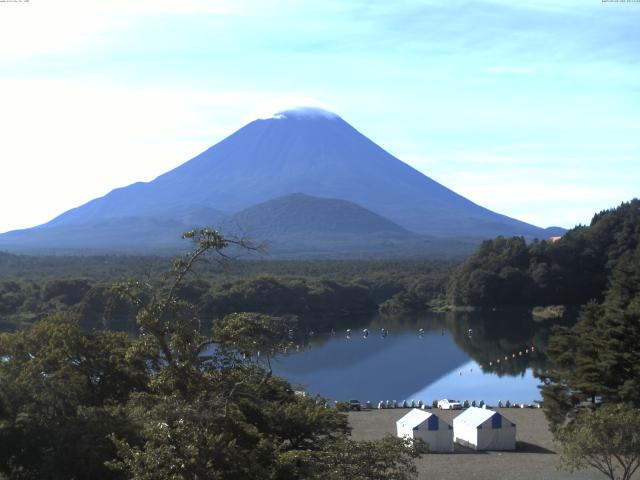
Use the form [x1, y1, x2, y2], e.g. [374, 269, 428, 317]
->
[0, 230, 419, 480]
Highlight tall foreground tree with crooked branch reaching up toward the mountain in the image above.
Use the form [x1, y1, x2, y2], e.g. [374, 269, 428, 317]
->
[109, 231, 415, 480]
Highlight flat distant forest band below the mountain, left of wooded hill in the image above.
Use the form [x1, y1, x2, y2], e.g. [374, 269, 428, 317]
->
[0, 254, 454, 331]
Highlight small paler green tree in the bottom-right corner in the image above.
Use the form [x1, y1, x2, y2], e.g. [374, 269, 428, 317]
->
[558, 404, 640, 480]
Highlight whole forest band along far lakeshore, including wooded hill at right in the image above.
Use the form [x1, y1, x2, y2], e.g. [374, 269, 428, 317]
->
[5, 200, 640, 330]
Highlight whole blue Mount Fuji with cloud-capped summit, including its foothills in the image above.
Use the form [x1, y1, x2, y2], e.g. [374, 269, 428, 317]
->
[0, 107, 562, 252]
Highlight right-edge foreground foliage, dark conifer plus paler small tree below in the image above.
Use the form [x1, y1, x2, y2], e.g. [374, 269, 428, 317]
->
[542, 218, 640, 480]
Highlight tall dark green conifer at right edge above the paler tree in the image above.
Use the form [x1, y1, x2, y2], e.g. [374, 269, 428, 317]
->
[542, 247, 640, 428]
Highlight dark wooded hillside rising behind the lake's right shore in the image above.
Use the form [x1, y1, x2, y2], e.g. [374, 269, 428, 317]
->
[447, 199, 640, 308]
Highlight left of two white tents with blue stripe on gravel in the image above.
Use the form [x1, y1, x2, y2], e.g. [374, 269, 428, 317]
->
[396, 408, 453, 453]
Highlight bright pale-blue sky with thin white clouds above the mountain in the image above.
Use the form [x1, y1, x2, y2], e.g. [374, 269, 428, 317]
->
[0, 0, 640, 231]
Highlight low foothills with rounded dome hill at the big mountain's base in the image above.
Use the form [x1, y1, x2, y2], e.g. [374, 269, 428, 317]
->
[0, 193, 477, 258]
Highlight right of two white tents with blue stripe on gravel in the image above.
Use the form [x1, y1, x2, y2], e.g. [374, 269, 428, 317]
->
[453, 407, 516, 450]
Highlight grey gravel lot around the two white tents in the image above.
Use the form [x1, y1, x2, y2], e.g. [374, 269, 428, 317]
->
[349, 408, 606, 480]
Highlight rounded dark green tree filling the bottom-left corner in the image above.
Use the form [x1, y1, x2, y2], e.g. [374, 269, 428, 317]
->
[0, 315, 148, 479]
